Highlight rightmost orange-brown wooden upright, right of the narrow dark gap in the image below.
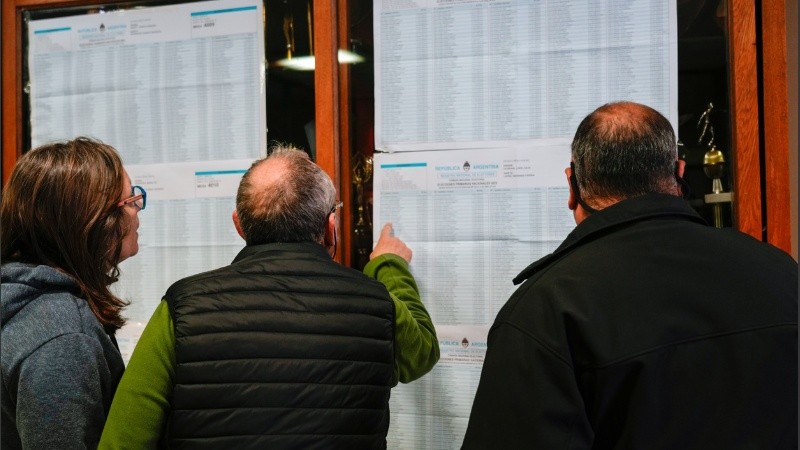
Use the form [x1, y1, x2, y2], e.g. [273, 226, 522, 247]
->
[761, 0, 792, 253]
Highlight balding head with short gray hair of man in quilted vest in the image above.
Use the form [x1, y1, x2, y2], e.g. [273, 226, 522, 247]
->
[236, 144, 336, 245]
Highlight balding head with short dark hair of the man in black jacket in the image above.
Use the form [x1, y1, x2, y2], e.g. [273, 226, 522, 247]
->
[572, 102, 678, 200]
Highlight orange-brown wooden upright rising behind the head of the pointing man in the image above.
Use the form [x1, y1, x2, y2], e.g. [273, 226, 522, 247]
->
[314, 0, 342, 261]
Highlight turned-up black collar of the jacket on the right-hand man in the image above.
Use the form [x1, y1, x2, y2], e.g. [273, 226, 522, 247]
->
[514, 194, 707, 284]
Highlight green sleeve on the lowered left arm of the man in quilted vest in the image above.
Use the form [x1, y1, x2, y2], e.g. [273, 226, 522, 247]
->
[98, 300, 175, 449]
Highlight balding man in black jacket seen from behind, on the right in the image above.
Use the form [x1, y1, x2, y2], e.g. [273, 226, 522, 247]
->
[463, 102, 798, 450]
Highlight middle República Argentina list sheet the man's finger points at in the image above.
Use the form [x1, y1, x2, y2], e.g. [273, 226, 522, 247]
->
[373, 140, 575, 325]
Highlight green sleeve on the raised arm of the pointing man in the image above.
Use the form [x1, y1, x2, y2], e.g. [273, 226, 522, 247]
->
[364, 254, 439, 384]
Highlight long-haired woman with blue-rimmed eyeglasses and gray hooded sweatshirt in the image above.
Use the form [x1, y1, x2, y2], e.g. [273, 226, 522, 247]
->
[0, 137, 146, 449]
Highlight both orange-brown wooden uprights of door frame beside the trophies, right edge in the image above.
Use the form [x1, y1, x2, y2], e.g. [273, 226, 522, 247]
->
[727, 0, 792, 254]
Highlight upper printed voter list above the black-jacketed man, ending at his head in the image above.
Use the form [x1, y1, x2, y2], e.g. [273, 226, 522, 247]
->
[374, 0, 678, 151]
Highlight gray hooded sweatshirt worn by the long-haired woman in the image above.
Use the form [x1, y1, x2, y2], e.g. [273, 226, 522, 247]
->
[0, 263, 125, 450]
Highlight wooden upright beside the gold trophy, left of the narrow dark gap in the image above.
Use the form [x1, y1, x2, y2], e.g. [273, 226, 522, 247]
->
[728, 0, 763, 240]
